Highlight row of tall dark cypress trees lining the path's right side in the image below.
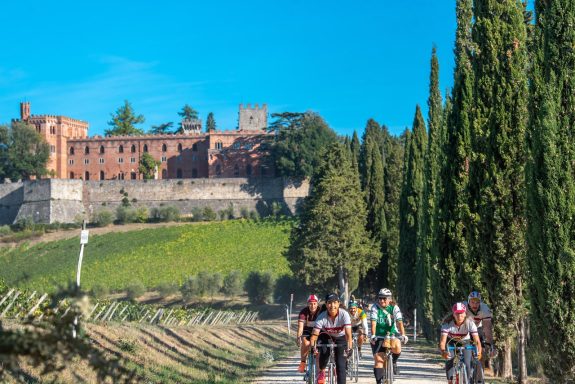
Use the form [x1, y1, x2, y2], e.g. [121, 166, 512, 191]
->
[397, 0, 575, 382]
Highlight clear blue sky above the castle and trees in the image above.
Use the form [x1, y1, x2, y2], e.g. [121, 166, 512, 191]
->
[0, 0, 462, 135]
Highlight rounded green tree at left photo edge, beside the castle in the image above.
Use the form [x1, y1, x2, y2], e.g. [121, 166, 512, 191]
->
[0, 121, 50, 180]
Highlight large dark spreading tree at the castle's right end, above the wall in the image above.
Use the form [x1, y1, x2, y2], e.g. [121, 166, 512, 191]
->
[269, 112, 337, 177]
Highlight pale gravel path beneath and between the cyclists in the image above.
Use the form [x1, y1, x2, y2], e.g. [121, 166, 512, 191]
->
[251, 344, 446, 384]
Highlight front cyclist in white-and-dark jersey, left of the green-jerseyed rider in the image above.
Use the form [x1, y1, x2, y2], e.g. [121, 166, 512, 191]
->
[310, 293, 353, 384]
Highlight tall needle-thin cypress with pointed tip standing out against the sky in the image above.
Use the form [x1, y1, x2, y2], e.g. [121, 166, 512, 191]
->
[416, 47, 443, 338]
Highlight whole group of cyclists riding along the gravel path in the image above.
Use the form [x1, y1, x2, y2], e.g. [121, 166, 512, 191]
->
[296, 288, 493, 384]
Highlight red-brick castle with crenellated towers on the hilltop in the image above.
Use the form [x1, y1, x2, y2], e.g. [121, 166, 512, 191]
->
[14, 102, 274, 181]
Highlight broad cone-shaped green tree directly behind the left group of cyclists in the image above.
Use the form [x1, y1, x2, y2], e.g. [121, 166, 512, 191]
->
[287, 143, 380, 301]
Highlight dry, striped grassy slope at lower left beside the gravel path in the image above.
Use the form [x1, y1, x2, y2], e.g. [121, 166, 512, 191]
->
[3, 323, 295, 384]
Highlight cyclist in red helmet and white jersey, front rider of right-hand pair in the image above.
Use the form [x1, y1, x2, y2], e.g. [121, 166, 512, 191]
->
[439, 303, 481, 384]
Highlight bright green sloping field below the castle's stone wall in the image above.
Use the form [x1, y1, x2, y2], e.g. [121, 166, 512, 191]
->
[0, 220, 291, 292]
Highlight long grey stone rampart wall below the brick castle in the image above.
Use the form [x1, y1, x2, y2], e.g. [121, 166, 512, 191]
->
[0, 178, 309, 225]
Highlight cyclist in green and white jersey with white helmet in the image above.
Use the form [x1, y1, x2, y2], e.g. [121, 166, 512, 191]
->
[370, 288, 408, 384]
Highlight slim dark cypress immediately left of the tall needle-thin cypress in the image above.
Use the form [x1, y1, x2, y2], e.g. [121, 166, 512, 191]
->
[397, 105, 427, 314]
